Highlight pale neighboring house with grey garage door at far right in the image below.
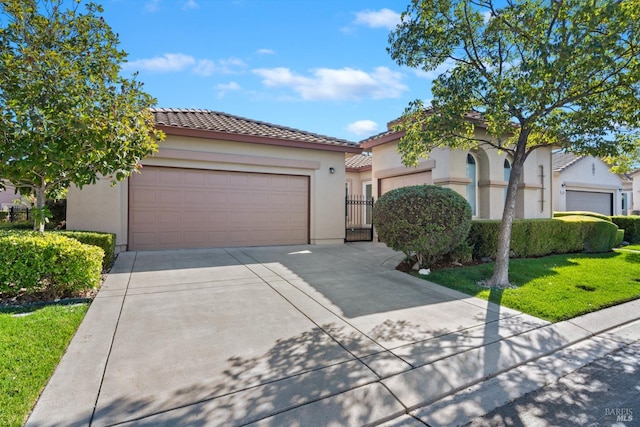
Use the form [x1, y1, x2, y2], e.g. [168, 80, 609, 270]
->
[553, 151, 633, 215]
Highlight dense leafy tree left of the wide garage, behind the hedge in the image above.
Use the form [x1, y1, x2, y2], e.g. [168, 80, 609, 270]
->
[0, 0, 163, 231]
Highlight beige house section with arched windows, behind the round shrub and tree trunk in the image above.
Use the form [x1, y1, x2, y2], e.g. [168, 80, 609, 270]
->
[360, 114, 553, 219]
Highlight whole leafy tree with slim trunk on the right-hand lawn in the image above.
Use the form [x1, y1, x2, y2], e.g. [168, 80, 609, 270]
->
[388, 0, 640, 287]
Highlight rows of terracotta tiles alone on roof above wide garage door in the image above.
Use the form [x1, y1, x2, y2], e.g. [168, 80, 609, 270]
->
[151, 108, 357, 147]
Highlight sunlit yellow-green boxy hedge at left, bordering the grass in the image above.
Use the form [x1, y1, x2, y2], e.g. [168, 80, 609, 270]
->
[0, 230, 104, 298]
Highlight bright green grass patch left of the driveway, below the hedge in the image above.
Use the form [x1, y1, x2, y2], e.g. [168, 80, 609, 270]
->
[0, 304, 89, 426]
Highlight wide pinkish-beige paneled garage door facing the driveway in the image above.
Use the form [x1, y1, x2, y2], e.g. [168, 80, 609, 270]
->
[129, 166, 309, 250]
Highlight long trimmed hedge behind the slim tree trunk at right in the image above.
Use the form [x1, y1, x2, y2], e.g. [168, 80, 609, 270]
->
[468, 219, 619, 259]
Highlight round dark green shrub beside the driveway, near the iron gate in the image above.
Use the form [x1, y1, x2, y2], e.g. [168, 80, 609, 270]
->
[373, 185, 471, 266]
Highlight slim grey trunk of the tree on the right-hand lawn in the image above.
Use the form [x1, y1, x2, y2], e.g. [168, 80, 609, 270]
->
[487, 131, 528, 288]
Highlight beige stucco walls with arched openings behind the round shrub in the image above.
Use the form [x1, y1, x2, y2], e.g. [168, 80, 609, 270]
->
[371, 134, 552, 219]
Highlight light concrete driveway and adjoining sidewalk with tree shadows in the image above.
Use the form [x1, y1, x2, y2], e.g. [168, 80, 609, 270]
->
[27, 243, 640, 426]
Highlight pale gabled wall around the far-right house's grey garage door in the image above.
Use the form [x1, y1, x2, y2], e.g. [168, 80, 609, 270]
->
[553, 156, 631, 215]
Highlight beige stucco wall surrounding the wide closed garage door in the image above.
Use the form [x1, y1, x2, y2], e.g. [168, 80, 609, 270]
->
[67, 135, 345, 248]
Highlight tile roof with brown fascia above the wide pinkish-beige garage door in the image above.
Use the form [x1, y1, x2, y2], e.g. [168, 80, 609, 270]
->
[151, 108, 361, 153]
